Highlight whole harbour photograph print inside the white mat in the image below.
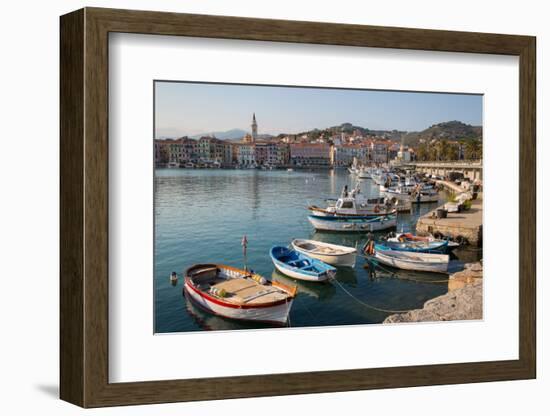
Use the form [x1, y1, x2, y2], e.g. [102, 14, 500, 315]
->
[153, 81, 483, 333]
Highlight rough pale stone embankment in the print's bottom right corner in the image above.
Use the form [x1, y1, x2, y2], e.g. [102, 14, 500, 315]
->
[384, 263, 483, 324]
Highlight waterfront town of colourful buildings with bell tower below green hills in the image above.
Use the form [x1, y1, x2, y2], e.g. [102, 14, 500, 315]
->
[154, 114, 481, 169]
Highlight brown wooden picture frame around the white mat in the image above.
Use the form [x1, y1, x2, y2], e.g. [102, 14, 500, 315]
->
[60, 8, 536, 407]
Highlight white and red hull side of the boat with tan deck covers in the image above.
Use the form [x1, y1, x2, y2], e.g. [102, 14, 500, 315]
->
[184, 281, 294, 325]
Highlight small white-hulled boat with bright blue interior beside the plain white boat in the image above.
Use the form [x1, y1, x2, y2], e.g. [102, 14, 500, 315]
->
[269, 246, 336, 282]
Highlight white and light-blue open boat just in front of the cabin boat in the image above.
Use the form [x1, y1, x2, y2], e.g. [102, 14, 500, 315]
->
[307, 214, 397, 232]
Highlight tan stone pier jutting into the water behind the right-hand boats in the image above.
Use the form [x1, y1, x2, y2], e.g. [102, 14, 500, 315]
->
[416, 198, 483, 247]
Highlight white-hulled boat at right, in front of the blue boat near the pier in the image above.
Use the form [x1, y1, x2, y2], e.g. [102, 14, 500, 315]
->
[371, 249, 449, 273]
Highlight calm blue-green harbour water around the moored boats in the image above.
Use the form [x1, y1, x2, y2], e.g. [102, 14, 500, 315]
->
[154, 169, 478, 333]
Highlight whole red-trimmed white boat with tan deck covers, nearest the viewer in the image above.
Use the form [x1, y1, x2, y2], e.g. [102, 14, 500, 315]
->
[184, 264, 296, 325]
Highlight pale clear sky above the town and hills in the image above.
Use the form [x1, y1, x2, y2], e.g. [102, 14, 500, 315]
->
[155, 81, 483, 138]
